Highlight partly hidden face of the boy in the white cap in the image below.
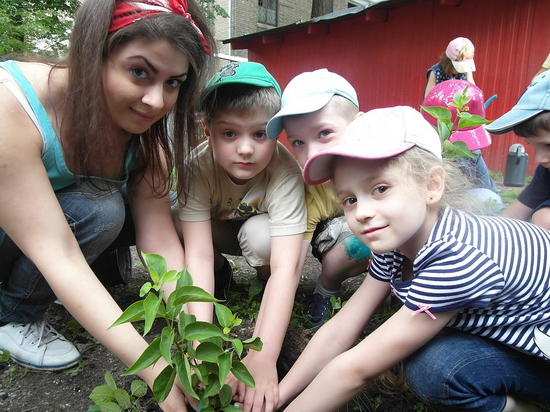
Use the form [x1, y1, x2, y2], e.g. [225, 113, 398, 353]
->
[283, 104, 351, 168]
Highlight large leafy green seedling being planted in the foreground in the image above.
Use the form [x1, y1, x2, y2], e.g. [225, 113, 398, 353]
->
[103, 253, 262, 412]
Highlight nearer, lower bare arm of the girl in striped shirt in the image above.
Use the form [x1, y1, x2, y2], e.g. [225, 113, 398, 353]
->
[285, 296, 456, 412]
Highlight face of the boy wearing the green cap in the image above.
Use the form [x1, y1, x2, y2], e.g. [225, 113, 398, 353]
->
[205, 110, 277, 185]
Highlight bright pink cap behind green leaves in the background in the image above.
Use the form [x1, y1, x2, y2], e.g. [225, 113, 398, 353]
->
[422, 80, 491, 150]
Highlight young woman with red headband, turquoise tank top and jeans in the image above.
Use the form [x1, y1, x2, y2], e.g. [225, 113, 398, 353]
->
[0, 0, 213, 411]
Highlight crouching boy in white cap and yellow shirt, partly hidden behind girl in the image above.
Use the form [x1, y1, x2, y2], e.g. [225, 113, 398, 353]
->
[267, 69, 370, 326]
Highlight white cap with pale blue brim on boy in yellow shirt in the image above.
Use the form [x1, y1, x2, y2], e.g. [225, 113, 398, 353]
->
[266, 69, 359, 139]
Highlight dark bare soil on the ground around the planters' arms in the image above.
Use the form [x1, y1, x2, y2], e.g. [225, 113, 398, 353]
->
[0, 177, 532, 412]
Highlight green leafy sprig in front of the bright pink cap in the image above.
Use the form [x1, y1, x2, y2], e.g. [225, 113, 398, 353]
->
[420, 86, 490, 159]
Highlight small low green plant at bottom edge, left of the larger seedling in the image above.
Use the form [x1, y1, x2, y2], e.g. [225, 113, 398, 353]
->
[88, 371, 147, 412]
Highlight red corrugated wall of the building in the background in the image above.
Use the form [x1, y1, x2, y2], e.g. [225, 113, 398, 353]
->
[244, 0, 550, 174]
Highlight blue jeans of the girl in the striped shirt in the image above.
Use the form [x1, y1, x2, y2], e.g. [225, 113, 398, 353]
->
[404, 328, 550, 411]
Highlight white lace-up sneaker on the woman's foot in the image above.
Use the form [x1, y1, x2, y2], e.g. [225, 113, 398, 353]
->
[0, 321, 80, 370]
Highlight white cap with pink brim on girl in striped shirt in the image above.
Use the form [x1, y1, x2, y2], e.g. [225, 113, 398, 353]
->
[304, 106, 441, 185]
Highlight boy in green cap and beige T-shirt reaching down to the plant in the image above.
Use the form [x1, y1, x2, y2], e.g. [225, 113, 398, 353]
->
[178, 62, 306, 411]
